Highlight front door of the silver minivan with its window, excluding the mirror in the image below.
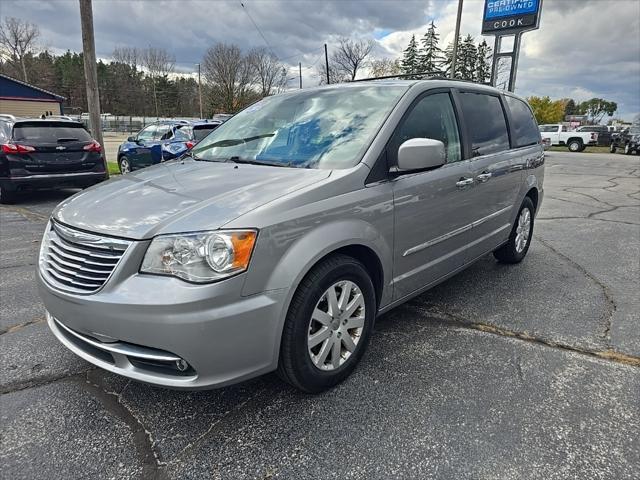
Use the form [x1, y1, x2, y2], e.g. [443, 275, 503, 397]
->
[387, 91, 474, 299]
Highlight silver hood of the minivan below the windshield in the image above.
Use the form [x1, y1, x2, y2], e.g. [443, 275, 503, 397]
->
[53, 160, 331, 240]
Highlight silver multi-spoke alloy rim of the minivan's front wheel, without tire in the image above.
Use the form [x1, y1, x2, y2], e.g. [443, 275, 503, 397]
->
[307, 280, 365, 370]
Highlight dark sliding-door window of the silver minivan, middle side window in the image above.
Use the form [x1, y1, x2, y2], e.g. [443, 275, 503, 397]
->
[460, 93, 509, 157]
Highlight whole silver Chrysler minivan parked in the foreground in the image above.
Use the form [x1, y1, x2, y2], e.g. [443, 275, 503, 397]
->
[38, 79, 544, 392]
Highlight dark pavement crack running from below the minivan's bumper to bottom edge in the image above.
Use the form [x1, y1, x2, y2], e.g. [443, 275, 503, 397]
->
[78, 372, 167, 480]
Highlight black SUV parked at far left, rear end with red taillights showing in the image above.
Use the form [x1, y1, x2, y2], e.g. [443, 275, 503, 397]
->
[0, 118, 108, 203]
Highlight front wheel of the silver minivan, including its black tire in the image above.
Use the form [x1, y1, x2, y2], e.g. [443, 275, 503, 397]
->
[278, 254, 377, 393]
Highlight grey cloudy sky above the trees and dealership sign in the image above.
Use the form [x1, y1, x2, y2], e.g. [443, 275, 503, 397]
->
[0, 0, 640, 119]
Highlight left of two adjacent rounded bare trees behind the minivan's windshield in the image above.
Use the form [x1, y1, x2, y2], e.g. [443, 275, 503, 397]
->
[202, 43, 256, 113]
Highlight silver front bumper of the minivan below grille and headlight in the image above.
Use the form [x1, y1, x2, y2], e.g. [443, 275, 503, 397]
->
[38, 266, 286, 389]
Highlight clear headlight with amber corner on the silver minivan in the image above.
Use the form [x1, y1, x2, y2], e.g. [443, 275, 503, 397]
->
[140, 230, 257, 283]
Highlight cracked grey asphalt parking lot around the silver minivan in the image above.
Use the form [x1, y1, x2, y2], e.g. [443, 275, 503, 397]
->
[0, 152, 640, 479]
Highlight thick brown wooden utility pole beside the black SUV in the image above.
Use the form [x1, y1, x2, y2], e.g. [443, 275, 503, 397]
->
[79, 0, 104, 167]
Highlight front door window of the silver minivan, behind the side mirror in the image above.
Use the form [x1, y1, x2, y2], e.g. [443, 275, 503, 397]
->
[388, 93, 462, 165]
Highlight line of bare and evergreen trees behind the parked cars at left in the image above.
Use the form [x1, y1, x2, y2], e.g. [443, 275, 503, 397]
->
[0, 17, 286, 117]
